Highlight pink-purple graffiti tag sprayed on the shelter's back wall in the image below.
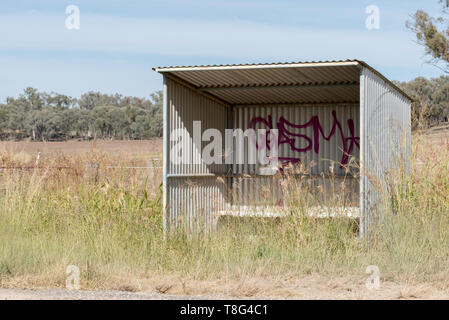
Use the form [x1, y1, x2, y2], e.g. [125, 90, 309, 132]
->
[249, 110, 360, 167]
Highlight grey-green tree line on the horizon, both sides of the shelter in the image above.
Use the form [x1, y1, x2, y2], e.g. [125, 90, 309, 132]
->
[0, 76, 449, 141]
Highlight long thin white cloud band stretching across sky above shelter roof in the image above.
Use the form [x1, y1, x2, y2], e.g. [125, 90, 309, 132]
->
[0, 11, 428, 67]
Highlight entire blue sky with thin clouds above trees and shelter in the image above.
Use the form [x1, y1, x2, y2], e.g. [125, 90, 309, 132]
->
[0, 0, 442, 102]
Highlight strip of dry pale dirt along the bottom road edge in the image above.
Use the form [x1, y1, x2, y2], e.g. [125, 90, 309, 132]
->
[0, 276, 449, 300]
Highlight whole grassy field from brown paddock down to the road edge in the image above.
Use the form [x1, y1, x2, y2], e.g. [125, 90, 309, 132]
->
[0, 130, 449, 299]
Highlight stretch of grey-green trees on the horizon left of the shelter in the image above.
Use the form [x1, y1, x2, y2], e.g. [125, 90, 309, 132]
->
[0, 87, 162, 141]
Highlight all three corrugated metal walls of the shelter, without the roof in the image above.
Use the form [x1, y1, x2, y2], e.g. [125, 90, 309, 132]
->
[164, 68, 410, 235]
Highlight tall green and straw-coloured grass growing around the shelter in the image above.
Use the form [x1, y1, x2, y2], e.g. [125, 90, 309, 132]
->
[0, 137, 449, 288]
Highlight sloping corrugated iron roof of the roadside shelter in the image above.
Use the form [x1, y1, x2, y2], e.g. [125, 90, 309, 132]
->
[153, 60, 411, 105]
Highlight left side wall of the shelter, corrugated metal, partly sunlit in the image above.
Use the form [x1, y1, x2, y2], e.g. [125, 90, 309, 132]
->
[164, 79, 227, 231]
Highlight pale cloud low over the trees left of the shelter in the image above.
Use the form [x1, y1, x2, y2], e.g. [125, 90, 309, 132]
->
[0, 57, 162, 103]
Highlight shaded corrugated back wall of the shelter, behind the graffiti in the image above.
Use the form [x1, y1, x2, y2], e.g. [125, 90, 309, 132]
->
[232, 104, 360, 206]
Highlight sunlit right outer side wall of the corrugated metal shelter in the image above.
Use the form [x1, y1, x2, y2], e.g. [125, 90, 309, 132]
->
[360, 68, 411, 236]
